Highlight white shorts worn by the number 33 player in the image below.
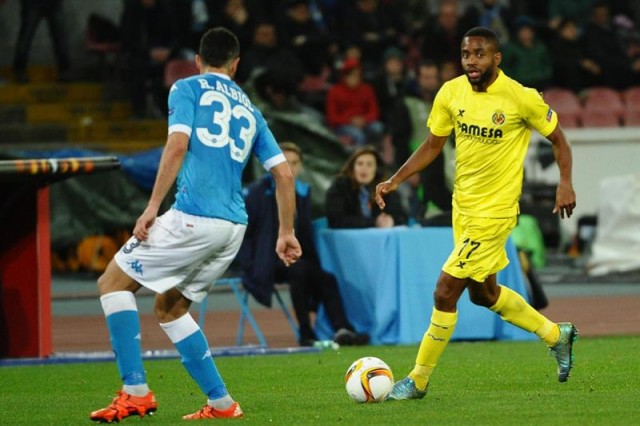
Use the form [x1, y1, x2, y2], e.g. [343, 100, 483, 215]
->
[114, 209, 247, 302]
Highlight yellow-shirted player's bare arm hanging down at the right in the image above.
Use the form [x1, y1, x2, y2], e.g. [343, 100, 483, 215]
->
[547, 125, 576, 219]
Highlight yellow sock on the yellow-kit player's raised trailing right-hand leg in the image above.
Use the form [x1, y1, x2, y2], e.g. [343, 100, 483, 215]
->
[489, 285, 560, 346]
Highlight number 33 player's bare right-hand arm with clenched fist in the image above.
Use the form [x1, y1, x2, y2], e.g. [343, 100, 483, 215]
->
[270, 162, 302, 266]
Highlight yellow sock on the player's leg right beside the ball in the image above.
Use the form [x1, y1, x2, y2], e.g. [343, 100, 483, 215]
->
[409, 308, 458, 390]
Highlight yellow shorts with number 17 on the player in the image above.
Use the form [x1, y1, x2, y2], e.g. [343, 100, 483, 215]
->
[442, 209, 517, 282]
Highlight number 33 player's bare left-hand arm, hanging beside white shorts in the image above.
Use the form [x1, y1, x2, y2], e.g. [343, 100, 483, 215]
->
[133, 132, 189, 241]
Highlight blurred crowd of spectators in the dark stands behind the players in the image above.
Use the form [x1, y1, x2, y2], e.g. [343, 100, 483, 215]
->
[14, 0, 640, 131]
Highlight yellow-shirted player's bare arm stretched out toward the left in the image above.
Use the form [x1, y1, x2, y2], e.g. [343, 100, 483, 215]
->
[376, 134, 448, 209]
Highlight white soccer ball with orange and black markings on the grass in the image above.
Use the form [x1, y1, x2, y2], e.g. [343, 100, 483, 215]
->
[344, 356, 393, 402]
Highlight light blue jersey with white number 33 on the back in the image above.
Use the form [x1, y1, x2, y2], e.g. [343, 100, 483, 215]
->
[169, 73, 286, 224]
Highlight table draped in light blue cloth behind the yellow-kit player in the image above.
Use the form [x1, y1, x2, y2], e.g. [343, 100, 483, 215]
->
[315, 227, 537, 344]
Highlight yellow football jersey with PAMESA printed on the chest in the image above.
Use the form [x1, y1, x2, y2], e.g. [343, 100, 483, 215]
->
[427, 70, 558, 217]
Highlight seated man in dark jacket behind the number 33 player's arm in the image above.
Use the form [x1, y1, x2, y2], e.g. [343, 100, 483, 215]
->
[237, 142, 369, 346]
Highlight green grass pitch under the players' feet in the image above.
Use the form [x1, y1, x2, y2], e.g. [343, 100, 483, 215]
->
[0, 337, 640, 425]
